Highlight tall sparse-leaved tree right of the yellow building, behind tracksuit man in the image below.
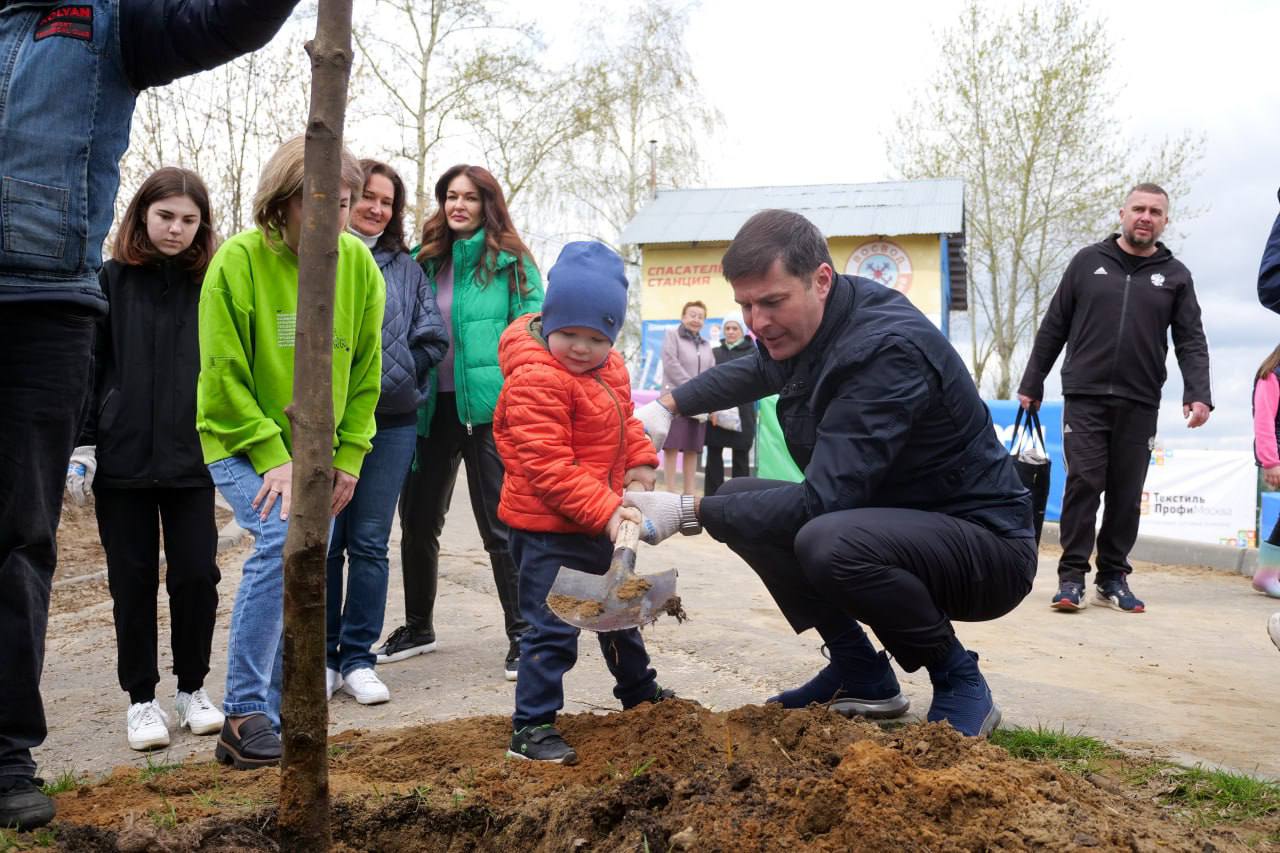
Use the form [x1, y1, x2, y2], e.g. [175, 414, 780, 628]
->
[890, 0, 1201, 398]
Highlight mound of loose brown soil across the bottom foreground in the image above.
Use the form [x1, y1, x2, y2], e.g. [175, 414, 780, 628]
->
[37, 699, 1247, 853]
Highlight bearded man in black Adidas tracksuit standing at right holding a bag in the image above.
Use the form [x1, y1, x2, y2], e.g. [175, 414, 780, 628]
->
[1018, 183, 1213, 613]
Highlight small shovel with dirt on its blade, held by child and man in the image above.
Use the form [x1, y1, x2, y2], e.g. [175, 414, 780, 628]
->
[547, 521, 684, 631]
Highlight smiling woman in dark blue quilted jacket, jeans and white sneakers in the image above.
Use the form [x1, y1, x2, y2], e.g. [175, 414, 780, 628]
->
[326, 160, 449, 704]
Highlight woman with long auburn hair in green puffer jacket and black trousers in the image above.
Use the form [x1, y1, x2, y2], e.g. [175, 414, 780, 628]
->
[378, 165, 543, 681]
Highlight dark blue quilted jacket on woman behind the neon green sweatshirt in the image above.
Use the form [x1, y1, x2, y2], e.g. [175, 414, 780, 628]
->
[374, 248, 449, 423]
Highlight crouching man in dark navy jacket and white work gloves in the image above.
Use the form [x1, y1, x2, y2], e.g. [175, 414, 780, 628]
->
[627, 210, 1036, 736]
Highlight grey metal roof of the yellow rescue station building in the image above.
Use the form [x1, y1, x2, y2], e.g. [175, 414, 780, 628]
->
[622, 178, 964, 243]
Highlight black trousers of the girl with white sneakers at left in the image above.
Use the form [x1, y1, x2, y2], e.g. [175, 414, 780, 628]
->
[93, 485, 220, 702]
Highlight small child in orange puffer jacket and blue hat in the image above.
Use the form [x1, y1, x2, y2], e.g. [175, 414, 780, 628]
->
[494, 242, 675, 765]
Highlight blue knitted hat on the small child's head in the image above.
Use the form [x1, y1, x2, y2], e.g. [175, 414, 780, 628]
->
[543, 241, 627, 341]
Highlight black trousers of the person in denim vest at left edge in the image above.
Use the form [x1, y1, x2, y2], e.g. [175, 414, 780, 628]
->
[0, 302, 93, 781]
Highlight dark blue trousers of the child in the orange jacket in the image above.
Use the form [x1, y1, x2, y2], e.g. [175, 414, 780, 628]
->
[511, 528, 658, 729]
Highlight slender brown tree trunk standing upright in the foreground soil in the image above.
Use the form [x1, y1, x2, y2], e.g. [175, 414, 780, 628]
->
[279, 0, 352, 850]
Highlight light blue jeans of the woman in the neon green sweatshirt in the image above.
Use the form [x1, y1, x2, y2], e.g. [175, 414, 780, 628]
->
[209, 456, 289, 730]
